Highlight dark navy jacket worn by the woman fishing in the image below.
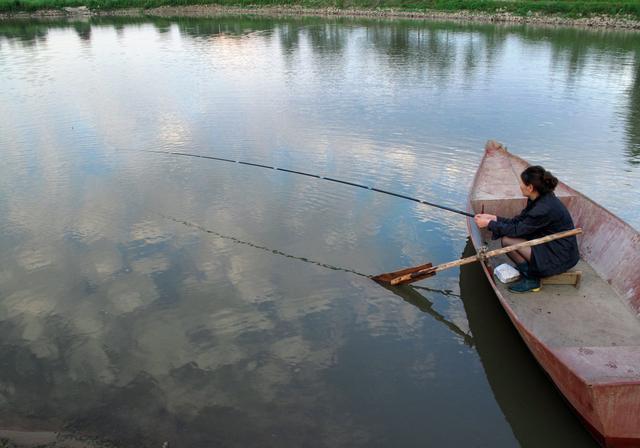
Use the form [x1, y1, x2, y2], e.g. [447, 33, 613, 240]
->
[489, 193, 580, 277]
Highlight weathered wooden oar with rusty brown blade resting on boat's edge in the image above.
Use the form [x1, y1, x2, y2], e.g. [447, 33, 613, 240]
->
[371, 228, 582, 286]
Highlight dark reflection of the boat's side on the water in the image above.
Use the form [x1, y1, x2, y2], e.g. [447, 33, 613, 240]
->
[458, 238, 594, 448]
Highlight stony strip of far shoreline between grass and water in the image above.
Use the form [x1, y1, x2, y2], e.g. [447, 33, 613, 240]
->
[0, 5, 640, 31]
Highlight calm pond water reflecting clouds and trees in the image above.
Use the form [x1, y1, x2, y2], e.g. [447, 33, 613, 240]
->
[0, 17, 640, 447]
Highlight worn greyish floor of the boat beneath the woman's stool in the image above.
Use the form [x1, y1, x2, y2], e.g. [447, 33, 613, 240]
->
[490, 241, 640, 347]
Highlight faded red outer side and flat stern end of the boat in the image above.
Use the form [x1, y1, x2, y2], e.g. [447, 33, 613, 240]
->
[467, 141, 640, 448]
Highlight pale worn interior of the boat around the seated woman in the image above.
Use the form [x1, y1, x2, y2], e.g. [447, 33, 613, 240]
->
[470, 151, 640, 352]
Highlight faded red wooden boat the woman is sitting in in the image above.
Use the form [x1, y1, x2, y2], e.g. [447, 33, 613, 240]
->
[467, 142, 640, 447]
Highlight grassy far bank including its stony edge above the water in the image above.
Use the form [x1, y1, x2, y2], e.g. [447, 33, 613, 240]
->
[0, 0, 640, 28]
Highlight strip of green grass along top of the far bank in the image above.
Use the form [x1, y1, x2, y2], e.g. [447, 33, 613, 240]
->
[0, 0, 640, 19]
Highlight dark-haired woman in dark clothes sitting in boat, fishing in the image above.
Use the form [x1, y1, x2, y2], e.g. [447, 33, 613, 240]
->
[475, 166, 580, 293]
